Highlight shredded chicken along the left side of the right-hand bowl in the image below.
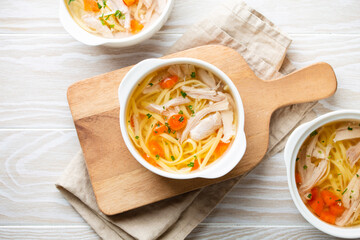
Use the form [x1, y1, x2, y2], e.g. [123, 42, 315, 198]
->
[297, 134, 332, 199]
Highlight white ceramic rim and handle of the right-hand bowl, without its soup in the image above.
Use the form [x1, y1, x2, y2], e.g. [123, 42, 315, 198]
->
[285, 110, 360, 238]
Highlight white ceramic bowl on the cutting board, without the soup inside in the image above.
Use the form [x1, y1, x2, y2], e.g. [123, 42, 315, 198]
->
[118, 58, 246, 179]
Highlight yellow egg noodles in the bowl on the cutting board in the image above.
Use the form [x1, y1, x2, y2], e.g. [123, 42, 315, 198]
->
[126, 66, 236, 174]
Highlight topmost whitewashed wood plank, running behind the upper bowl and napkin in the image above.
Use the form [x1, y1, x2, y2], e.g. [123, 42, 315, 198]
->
[0, 0, 360, 34]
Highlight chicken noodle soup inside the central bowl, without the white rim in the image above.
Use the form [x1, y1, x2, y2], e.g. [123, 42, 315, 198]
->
[126, 64, 236, 174]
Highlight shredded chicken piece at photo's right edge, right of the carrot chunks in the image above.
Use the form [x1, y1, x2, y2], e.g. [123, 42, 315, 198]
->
[335, 170, 360, 226]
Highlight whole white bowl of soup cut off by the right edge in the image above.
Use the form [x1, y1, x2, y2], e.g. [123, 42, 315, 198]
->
[285, 110, 360, 238]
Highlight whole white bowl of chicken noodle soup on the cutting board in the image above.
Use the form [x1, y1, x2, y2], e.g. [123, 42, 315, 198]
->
[119, 58, 246, 179]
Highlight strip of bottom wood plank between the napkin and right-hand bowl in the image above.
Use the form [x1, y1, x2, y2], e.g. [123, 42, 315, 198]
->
[186, 225, 338, 240]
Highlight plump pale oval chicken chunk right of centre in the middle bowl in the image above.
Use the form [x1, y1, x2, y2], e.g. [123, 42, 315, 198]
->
[190, 112, 222, 141]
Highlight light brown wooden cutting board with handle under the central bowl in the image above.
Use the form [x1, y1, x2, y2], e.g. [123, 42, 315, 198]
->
[67, 45, 337, 215]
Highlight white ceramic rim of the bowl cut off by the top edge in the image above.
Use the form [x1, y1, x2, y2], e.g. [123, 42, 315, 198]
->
[59, 0, 175, 47]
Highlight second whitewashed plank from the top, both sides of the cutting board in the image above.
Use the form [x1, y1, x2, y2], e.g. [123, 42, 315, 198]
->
[0, 34, 360, 128]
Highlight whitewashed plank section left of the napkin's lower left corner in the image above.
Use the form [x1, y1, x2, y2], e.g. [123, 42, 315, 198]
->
[0, 130, 84, 226]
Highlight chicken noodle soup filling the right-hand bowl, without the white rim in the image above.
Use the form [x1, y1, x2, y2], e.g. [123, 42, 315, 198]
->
[295, 121, 360, 226]
